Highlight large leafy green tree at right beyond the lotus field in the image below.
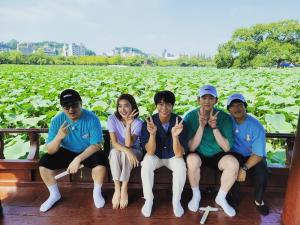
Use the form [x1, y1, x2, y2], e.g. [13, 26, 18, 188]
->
[215, 20, 300, 68]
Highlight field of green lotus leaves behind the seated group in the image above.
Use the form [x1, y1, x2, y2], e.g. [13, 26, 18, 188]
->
[0, 64, 300, 164]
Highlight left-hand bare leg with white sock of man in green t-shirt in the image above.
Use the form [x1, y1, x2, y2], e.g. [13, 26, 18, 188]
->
[186, 153, 202, 212]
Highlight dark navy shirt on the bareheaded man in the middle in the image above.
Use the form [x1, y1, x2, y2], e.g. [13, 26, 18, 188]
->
[140, 113, 188, 159]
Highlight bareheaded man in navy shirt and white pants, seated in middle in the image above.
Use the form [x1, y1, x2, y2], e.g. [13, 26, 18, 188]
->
[141, 91, 188, 217]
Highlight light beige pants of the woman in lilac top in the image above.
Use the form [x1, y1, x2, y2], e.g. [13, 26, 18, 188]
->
[108, 148, 142, 182]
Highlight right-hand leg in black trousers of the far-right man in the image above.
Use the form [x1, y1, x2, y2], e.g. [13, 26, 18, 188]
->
[253, 159, 269, 216]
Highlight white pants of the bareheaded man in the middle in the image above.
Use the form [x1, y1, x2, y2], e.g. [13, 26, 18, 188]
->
[141, 154, 186, 201]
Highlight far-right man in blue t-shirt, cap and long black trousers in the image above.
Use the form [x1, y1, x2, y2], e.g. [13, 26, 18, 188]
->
[227, 94, 269, 215]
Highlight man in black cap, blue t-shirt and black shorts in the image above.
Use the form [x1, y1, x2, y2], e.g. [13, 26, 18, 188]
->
[39, 89, 108, 212]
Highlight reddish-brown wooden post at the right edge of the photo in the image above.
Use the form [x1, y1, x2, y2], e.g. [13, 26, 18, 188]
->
[282, 113, 300, 225]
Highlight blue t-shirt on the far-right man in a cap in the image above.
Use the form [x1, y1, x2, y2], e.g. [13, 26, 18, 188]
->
[231, 115, 266, 157]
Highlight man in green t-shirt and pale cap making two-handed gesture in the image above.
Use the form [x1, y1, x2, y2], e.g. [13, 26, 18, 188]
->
[184, 85, 239, 216]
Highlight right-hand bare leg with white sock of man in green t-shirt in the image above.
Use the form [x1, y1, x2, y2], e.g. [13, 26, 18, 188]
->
[215, 155, 239, 216]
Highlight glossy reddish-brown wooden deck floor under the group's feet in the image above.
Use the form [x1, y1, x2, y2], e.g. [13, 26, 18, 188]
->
[0, 185, 284, 225]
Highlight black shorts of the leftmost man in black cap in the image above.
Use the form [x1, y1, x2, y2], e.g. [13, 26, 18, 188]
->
[39, 147, 108, 170]
